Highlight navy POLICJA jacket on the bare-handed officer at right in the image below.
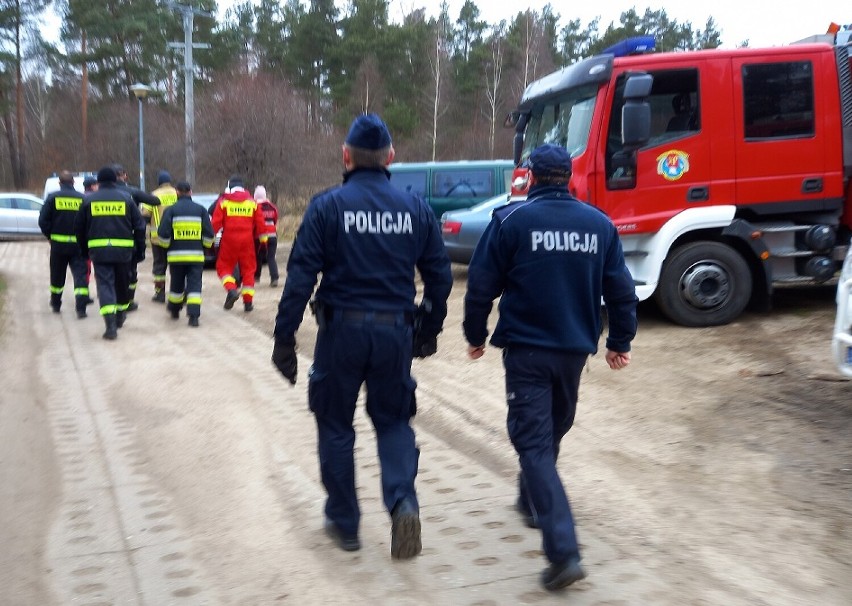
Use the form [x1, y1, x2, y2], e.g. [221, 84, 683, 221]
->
[464, 185, 638, 354]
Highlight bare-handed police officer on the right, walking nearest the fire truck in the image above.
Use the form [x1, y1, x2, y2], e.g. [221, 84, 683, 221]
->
[464, 144, 638, 590]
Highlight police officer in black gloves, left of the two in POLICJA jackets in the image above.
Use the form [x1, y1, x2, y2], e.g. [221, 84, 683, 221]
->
[272, 114, 453, 559]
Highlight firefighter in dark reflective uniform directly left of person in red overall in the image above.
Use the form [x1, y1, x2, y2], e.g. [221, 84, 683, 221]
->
[157, 181, 213, 326]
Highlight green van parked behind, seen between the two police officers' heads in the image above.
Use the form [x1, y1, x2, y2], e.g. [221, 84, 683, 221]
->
[388, 160, 515, 219]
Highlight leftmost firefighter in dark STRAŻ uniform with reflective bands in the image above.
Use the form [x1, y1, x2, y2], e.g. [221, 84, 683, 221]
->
[38, 170, 91, 318]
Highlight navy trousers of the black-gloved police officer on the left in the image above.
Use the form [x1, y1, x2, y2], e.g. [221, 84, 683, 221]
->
[308, 311, 420, 536]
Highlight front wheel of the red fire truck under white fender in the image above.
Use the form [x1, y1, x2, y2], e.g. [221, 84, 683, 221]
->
[655, 242, 752, 327]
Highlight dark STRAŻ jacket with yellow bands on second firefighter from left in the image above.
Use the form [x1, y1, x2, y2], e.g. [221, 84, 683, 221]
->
[74, 183, 145, 263]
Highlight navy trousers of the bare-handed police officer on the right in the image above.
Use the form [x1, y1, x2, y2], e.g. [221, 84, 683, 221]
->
[503, 345, 588, 564]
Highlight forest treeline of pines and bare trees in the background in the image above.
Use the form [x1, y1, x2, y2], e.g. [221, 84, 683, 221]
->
[0, 0, 732, 198]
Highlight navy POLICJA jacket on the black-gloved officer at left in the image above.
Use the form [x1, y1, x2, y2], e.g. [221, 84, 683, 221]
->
[275, 168, 453, 339]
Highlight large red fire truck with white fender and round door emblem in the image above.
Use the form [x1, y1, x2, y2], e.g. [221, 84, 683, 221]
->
[508, 31, 852, 326]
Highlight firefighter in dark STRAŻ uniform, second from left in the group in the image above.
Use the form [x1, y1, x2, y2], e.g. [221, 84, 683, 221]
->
[74, 166, 145, 340]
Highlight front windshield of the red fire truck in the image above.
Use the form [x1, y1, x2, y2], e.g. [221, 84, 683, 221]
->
[521, 84, 598, 160]
